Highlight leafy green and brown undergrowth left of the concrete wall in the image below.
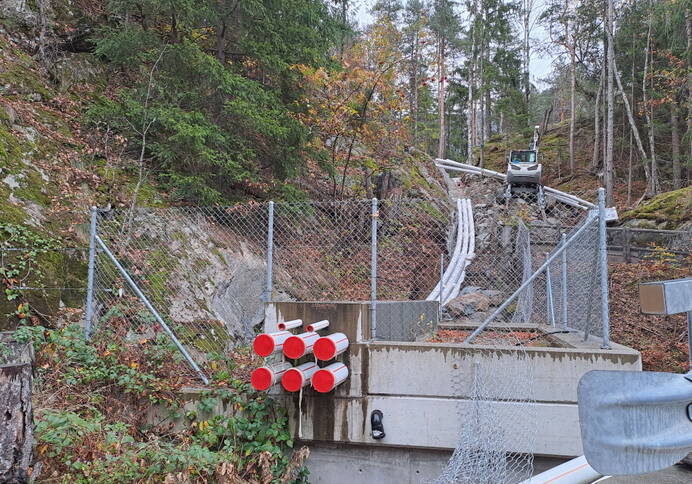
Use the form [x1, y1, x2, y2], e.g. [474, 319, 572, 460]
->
[16, 326, 308, 484]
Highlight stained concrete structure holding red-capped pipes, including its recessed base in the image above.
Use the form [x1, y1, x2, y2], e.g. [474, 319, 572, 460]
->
[265, 302, 641, 482]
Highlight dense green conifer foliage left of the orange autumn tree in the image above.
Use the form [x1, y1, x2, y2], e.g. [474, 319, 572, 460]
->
[88, 0, 344, 205]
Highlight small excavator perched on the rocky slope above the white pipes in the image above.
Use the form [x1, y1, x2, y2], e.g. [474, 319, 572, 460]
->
[504, 126, 545, 210]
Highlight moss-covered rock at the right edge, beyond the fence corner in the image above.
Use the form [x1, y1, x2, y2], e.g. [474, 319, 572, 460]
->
[622, 187, 692, 230]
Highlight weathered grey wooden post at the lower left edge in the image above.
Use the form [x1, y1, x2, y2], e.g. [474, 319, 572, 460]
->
[0, 334, 33, 483]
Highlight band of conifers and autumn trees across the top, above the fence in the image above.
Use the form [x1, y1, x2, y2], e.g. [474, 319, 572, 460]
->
[5, 0, 692, 206]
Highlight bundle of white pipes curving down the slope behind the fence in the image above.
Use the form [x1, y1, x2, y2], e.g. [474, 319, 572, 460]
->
[426, 198, 476, 306]
